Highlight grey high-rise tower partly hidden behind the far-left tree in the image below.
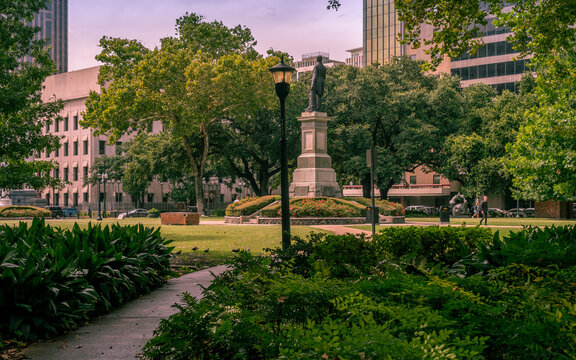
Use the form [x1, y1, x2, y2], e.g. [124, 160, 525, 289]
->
[30, 0, 68, 73]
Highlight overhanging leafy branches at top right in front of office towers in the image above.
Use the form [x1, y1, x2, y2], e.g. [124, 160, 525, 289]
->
[395, 0, 576, 70]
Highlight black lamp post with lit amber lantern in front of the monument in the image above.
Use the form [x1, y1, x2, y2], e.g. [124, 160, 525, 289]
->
[270, 59, 295, 249]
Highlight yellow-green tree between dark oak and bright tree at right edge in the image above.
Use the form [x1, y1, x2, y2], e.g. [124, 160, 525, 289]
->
[434, 74, 537, 197]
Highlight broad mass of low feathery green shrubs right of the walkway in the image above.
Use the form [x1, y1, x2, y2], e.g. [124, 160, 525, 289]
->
[144, 229, 576, 360]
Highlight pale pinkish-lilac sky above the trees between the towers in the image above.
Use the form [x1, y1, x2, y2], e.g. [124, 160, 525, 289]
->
[68, 0, 362, 71]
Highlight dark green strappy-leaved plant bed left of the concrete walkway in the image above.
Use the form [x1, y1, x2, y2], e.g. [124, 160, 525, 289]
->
[0, 219, 172, 340]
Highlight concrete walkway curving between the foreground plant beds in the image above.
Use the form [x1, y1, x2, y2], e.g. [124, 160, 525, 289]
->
[23, 266, 226, 360]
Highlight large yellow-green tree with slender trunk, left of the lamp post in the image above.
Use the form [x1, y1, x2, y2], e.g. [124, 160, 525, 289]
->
[83, 14, 273, 212]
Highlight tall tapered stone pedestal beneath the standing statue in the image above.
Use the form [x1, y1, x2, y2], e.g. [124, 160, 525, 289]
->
[290, 111, 342, 198]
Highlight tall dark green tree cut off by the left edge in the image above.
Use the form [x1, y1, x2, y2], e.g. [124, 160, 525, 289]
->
[0, 0, 63, 190]
